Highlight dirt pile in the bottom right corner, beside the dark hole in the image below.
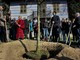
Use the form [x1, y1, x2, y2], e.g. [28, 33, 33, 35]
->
[57, 47, 80, 60]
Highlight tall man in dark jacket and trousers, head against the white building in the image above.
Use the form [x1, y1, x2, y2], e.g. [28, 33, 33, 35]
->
[51, 12, 60, 41]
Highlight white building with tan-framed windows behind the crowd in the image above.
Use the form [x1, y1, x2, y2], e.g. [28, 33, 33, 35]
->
[1, 0, 68, 19]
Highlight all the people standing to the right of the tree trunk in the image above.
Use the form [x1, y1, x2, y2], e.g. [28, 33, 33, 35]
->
[41, 12, 80, 43]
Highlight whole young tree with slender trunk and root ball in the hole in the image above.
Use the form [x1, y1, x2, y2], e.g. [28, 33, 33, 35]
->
[26, 0, 49, 60]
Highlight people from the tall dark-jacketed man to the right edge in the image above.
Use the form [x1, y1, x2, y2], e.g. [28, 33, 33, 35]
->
[51, 12, 80, 44]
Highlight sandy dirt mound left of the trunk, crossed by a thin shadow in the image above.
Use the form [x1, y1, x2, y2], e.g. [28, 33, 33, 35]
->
[0, 40, 35, 60]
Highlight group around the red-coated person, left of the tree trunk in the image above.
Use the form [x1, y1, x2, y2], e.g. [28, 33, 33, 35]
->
[9, 16, 38, 40]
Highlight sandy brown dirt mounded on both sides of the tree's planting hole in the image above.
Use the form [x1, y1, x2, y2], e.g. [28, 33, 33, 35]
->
[0, 40, 80, 60]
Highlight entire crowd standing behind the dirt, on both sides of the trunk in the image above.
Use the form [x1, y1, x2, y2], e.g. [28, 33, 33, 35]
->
[0, 12, 80, 43]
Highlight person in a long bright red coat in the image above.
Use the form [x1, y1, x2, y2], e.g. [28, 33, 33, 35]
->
[16, 16, 25, 39]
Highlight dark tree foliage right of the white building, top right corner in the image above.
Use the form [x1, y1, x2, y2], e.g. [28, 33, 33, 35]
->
[67, 0, 80, 20]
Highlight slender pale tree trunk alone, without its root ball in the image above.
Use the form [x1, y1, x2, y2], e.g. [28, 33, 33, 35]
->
[36, 0, 46, 52]
